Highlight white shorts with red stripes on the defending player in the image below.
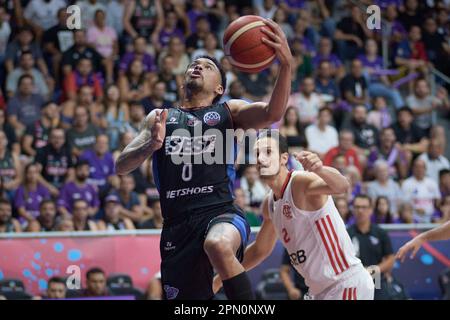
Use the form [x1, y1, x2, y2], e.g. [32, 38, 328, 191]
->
[309, 265, 375, 300]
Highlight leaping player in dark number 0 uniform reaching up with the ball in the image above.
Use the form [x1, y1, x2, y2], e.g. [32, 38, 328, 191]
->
[116, 20, 292, 300]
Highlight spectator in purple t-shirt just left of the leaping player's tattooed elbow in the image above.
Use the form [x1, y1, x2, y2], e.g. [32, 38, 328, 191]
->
[80, 134, 119, 194]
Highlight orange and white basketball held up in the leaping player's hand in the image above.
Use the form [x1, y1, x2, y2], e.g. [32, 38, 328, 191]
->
[223, 15, 276, 73]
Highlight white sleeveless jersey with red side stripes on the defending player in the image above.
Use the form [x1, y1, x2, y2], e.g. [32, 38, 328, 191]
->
[269, 171, 362, 295]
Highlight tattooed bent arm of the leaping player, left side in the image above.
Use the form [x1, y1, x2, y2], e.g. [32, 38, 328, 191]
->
[116, 109, 167, 175]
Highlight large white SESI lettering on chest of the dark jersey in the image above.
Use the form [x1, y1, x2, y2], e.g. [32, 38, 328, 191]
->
[165, 135, 216, 156]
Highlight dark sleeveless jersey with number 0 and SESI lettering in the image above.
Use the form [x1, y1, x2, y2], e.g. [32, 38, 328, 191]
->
[153, 103, 237, 222]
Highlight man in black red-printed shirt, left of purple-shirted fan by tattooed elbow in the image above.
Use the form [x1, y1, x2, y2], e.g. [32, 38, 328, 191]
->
[34, 127, 74, 197]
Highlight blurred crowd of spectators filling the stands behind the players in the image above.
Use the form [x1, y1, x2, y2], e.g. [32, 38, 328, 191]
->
[0, 0, 450, 238]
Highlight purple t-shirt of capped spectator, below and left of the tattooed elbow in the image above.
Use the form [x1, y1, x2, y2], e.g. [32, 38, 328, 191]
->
[57, 182, 100, 213]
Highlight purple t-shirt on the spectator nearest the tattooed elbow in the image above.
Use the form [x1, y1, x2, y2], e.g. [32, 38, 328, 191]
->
[80, 149, 115, 187]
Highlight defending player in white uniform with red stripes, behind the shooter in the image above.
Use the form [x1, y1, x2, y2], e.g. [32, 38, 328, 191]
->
[214, 131, 374, 300]
